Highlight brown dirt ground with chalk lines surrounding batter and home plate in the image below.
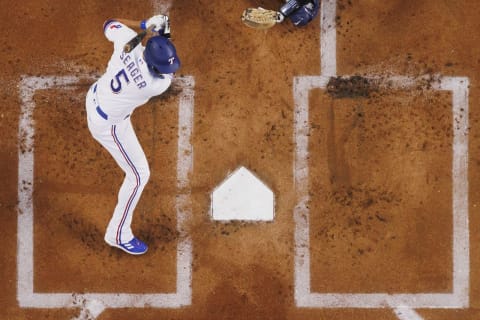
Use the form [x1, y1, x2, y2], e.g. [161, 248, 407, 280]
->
[0, 0, 480, 320]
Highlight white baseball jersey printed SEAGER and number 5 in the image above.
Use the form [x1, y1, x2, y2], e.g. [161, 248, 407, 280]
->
[96, 20, 173, 124]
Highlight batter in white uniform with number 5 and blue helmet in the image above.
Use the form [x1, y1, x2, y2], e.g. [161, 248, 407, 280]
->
[86, 15, 180, 255]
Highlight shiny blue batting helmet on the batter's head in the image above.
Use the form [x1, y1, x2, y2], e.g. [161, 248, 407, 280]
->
[143, 36, 180, 74]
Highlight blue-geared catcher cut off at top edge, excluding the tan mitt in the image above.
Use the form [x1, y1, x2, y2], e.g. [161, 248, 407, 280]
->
[279, 0, 320, 27]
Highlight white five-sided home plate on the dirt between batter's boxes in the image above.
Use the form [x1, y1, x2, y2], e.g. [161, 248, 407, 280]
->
[211, 167, 275, 221]
